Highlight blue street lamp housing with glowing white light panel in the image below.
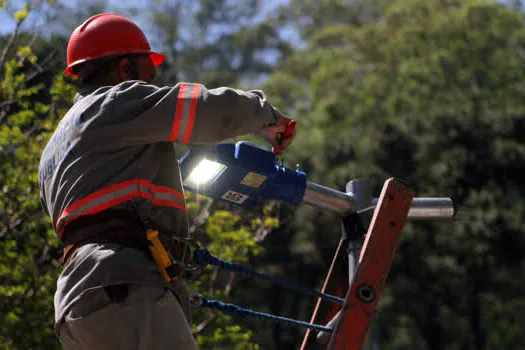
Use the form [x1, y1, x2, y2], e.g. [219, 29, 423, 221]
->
[180, 142, 307, 206]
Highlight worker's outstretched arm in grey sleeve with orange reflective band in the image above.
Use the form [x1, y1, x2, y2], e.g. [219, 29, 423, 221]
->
[112, 82, 293, 147]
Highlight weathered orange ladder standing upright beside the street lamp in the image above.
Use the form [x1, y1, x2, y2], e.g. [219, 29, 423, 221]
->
[301, 178, 414, 350]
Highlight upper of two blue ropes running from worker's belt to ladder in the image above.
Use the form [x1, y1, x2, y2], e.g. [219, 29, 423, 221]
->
[193, 248, 345, 304]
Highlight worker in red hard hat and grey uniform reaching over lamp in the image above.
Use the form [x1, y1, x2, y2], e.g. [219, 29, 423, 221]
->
[38, 13, 295, 350]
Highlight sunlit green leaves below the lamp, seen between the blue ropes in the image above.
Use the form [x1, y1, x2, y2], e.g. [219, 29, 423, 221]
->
[188, 202, 279, 349]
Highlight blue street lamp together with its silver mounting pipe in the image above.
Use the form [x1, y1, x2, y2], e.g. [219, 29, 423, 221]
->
[180, 142, 455, 220]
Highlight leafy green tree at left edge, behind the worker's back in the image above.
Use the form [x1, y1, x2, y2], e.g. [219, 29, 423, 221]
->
[0, 7, 72, 349]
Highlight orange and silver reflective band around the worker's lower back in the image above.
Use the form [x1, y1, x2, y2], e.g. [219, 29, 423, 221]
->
[57, 179, 186, 238]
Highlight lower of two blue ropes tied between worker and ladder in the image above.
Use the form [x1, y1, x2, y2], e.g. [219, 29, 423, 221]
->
[199, 295, 333, 333]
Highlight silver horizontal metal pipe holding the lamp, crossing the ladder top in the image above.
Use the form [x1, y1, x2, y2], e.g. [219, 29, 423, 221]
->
[303, 181, 455, 220]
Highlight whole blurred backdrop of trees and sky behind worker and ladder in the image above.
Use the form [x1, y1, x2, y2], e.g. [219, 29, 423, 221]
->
[0, 0, 525, 350]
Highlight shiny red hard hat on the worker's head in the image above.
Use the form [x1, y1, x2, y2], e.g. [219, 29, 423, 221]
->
[64, 13, 166, 77]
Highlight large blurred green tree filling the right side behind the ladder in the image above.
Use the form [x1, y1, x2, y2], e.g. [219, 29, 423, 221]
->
[268, 0, 525, 349]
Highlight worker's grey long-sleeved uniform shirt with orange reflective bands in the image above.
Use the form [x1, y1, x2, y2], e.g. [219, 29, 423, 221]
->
[38, 81, 279, 325]
